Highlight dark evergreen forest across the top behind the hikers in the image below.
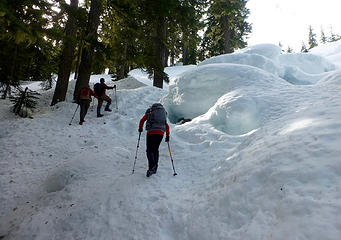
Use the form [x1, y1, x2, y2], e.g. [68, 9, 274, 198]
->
[0, 0, 251, 105]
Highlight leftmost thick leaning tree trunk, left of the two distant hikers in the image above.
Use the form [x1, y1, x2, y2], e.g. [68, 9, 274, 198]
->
[51, 0, 78, 106]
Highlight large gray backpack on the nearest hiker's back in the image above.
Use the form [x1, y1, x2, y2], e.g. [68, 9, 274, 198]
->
[146, 103, 167, 132]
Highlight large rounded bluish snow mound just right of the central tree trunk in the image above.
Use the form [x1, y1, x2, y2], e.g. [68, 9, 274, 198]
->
[163, 64, 290, 129]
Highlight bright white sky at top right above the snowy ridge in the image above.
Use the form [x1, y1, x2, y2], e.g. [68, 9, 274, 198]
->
[247, 0, 341, 51]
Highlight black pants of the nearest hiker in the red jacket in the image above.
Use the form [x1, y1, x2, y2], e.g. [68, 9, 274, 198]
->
[147, 134, 163, 172]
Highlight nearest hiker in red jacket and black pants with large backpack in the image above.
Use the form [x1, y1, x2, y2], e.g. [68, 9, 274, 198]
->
[138, 103, 169, 177]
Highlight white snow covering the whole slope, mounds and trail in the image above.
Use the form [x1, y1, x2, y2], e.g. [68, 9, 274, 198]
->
[0, 42, 341, 240]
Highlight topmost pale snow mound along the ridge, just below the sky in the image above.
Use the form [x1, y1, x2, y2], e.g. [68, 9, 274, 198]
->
[199, 44, 335, 85]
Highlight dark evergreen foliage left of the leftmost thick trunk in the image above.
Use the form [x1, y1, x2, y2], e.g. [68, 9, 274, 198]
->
[0, 0, 59, 98]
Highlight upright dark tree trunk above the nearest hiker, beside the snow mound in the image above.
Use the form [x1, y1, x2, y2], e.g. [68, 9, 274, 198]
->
[153, 17, 166, 88]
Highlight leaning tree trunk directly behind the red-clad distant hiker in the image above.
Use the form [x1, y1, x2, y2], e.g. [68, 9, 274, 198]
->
[73, 0, 102, 99]
